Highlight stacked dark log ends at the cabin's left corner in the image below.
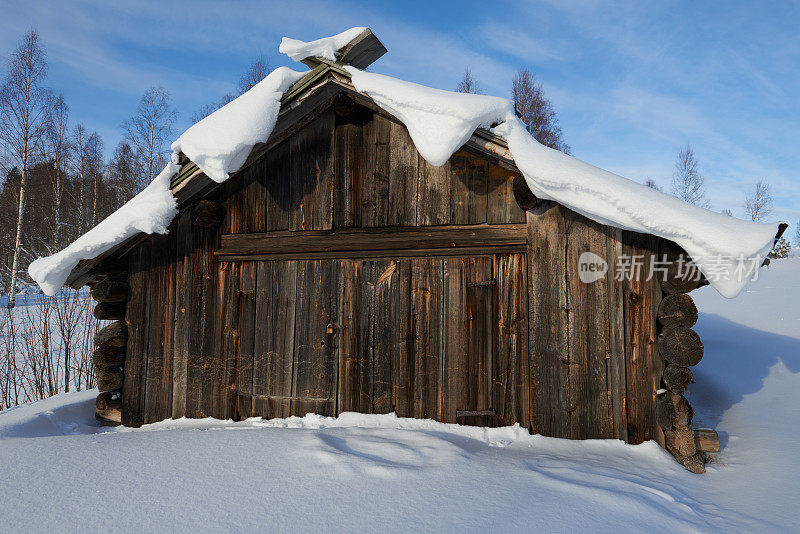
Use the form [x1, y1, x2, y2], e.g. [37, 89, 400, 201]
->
[89, 271, 128, 426]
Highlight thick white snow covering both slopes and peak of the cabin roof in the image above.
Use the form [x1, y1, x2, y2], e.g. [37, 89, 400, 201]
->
[28, 27, 778, 297]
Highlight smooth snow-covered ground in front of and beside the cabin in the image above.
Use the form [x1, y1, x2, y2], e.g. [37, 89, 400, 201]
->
[0, 258, 800, 533]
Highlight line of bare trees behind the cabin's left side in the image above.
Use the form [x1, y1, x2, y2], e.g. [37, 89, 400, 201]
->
[0, 30, 269, 307]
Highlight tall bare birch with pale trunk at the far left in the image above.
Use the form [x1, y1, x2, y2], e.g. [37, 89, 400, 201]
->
[0, 30, 52, 308]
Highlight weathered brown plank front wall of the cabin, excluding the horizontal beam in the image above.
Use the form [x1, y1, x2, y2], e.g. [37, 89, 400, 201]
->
[123, 101, 660, 443]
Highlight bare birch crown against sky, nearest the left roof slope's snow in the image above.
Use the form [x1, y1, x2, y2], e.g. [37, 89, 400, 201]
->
[122, 87, 178, 188]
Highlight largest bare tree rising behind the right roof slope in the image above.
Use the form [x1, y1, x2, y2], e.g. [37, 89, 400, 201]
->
[511, 68, 571, 154]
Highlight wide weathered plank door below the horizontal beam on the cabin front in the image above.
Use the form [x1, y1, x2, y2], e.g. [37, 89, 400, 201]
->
[244, 254, 528, 426]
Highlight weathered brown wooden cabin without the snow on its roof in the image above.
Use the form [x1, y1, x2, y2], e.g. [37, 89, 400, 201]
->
[68, 33, 764, 471]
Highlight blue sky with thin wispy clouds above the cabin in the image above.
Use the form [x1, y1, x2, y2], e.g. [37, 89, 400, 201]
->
[0, 0, 800, 230]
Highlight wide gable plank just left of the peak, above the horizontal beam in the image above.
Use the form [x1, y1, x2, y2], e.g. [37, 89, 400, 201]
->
[289, 109, 335, 230]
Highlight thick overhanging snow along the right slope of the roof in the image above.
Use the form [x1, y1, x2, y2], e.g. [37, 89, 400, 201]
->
[345, 66, 779, 298]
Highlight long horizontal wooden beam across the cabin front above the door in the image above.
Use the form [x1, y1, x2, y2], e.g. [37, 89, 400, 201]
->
[214, 224, 527, 261]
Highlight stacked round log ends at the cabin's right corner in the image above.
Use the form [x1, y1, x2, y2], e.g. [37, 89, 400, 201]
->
[655, 244, 719, 473]
